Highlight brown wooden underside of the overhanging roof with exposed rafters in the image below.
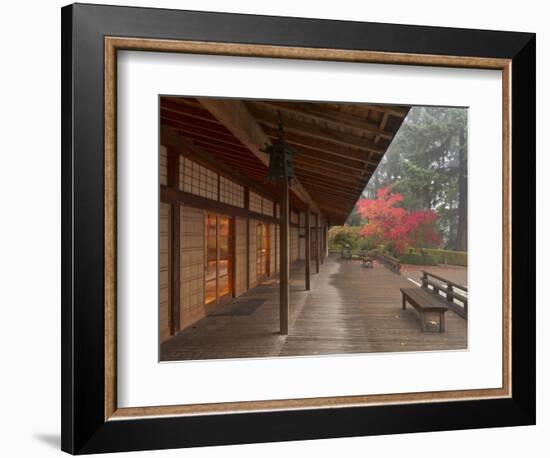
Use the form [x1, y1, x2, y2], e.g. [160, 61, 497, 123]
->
[160, 97, 410, 224]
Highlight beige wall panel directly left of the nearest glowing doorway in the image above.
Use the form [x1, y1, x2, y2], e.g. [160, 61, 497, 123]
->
[180, 205, 205, 329]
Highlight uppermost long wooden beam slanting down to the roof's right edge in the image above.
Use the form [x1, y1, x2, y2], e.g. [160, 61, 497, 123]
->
[254, 100, 393, 139]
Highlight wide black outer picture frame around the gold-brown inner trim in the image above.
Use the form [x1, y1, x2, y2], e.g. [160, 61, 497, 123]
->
[61, 4, 536, 454]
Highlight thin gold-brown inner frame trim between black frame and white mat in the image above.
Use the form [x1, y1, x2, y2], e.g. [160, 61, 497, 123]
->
[104, 37, 512, 421]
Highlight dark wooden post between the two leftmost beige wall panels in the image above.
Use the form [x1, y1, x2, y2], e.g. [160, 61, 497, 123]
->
[167, 149, 180, 335]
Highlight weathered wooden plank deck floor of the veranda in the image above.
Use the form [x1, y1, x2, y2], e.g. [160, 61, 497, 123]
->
[161, 257, 467, 361]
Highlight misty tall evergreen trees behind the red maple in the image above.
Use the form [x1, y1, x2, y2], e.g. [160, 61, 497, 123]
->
[364, 107, 468, 250]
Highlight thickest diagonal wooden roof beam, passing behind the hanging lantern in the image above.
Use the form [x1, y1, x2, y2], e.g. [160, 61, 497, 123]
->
[198, 99, 319, 216]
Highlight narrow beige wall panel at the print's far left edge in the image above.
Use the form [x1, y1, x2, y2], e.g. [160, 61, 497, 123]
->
[159, 203, 171, 342]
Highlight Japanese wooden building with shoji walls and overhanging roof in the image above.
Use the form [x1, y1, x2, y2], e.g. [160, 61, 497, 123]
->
[159, 96, 409, 342]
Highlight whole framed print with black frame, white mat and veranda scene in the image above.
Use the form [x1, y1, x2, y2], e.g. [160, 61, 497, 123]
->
[62, 5, 536, 454]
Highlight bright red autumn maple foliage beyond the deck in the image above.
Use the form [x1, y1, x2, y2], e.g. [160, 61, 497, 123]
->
[357, 186, 441, 254]
